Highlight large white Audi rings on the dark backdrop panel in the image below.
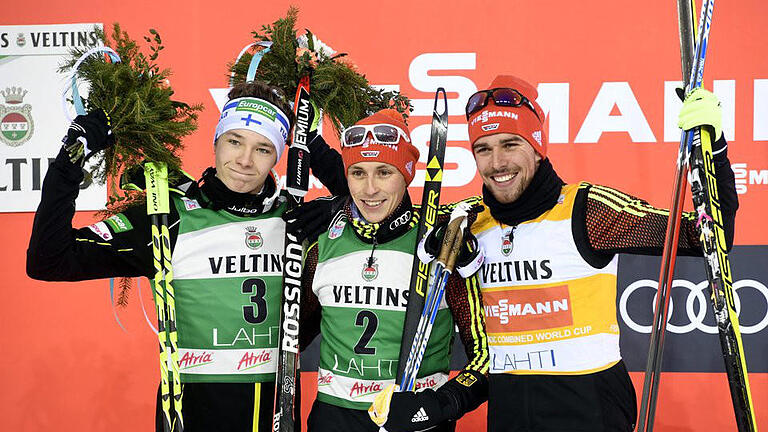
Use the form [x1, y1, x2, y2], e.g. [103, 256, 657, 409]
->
[619, 279, 768, 334]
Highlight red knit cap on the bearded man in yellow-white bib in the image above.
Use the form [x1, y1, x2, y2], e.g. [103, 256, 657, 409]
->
[469, 75, 547, 158]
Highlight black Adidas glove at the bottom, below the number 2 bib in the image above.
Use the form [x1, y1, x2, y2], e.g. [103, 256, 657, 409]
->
[376, 370, 488, 432]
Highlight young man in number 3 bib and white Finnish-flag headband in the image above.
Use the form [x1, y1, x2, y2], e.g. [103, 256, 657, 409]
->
[27, 83, 308, 432]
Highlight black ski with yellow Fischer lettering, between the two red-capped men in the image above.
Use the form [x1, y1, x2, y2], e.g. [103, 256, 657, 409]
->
[395, 87, 448, 388]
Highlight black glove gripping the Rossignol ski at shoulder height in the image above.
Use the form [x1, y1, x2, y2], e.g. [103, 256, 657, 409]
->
[283, 196, 347, 242]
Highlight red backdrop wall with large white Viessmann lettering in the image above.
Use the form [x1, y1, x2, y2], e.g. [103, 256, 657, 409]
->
[0, 0, 768, 431]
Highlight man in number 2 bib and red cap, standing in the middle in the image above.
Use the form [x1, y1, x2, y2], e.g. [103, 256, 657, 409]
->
[286, 110, 487, 432]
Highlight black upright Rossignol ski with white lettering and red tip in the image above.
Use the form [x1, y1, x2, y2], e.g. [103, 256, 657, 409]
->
[272, 75, 313, 432]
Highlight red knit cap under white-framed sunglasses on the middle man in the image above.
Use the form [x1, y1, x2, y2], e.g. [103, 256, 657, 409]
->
[341, 109, 419, 185]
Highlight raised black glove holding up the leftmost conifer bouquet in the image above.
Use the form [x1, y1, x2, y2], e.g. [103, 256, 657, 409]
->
[61, 109, 115, 166]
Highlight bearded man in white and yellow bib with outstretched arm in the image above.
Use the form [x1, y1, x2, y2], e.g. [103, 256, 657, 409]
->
[466, 76, 738, 432]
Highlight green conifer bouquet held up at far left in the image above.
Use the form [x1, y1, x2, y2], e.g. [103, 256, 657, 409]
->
[59, 23, 203, 207]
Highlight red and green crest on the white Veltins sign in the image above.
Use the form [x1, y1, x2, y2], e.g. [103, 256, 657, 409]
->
[0, 87, 35, 147]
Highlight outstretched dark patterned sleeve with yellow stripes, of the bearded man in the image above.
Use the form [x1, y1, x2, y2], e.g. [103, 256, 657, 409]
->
[573, 134, 739, 267]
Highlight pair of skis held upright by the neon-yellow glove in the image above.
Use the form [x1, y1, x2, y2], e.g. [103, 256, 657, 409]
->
[637, 0, 757, 432]
